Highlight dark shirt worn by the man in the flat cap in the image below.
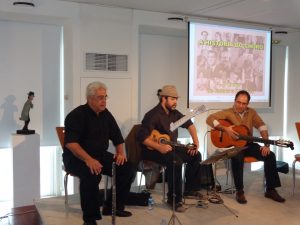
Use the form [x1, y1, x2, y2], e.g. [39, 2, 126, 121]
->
[137, 103, 193, 143]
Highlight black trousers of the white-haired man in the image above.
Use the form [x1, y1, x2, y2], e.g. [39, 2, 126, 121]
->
[63, 152, 134, 221]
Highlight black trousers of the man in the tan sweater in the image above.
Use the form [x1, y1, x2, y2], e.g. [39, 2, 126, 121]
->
[231, 143, 281, 190]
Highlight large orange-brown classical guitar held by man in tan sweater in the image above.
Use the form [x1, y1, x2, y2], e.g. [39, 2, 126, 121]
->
[211, 120, 294, 150]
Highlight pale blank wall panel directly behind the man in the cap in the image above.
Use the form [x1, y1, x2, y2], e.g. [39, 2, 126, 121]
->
[139, 33, 188, 118]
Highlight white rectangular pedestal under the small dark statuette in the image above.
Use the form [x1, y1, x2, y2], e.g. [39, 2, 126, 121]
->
[12, 134, 40, 207]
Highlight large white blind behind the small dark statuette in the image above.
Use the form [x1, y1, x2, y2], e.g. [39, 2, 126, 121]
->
[0, 20, 61, 148]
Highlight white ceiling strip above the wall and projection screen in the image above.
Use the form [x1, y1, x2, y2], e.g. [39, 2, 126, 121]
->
[60, 0, 300, 32]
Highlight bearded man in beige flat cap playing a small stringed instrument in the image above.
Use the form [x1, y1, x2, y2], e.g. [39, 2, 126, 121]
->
[137, 85, 201, 212]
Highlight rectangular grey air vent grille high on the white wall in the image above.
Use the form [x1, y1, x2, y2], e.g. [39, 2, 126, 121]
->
[85, 53, 128, 71]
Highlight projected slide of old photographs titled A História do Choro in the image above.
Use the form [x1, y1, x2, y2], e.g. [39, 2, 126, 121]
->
[189, 21, 271, 107]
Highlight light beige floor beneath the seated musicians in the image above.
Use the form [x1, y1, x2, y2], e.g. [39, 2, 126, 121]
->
[36, 172, 300, 225]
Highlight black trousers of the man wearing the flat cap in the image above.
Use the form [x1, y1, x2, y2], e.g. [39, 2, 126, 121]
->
[142, 148, 201, 203]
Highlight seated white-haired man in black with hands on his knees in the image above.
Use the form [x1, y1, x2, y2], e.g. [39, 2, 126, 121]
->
[63, 82, 133, 225]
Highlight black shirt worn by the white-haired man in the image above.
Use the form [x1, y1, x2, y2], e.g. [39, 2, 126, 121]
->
[64, 104, 124, 159]
